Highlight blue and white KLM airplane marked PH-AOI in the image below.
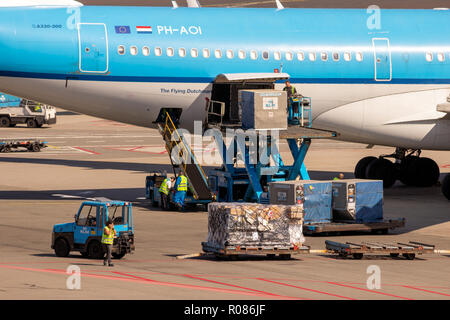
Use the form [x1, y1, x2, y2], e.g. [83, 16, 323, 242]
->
[0, 0, 450, 198]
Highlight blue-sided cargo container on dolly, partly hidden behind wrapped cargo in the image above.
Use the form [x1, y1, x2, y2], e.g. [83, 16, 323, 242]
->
[270, 180, 332, 224]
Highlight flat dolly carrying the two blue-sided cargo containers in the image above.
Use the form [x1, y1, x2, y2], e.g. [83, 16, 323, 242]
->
[303, 218, 406, 235]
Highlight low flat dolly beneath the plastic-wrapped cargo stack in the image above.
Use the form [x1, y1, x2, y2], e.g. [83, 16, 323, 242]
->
[202, 242, 310, 259]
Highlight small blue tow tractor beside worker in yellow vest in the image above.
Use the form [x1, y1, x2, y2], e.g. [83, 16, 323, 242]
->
[51, 201, 135, 259]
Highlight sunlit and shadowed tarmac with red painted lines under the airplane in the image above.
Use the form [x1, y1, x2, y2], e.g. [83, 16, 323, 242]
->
[0, 110, 450, 300]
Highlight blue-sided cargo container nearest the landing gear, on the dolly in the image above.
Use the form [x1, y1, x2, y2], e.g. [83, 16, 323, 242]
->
[332, 179, 383, 222]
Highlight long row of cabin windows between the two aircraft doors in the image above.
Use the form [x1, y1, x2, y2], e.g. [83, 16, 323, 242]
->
[118, 45, 364, 61]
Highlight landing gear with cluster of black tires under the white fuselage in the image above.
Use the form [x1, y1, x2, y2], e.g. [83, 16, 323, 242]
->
[355, 148, 440, 188]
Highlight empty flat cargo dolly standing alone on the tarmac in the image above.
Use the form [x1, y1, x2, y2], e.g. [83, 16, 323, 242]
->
[325, 240, 435, 260]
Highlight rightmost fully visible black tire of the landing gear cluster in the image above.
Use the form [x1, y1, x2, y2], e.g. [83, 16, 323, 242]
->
[407, 158, 440, 187]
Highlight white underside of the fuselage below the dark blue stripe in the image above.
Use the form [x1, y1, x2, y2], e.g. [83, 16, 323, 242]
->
[0, 77, 450, 150]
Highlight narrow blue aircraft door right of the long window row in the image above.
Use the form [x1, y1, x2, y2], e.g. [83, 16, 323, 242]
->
[372, 38, 392, 81]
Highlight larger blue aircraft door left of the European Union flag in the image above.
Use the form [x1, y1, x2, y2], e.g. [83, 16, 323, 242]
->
[78, 23, 109, 73]
